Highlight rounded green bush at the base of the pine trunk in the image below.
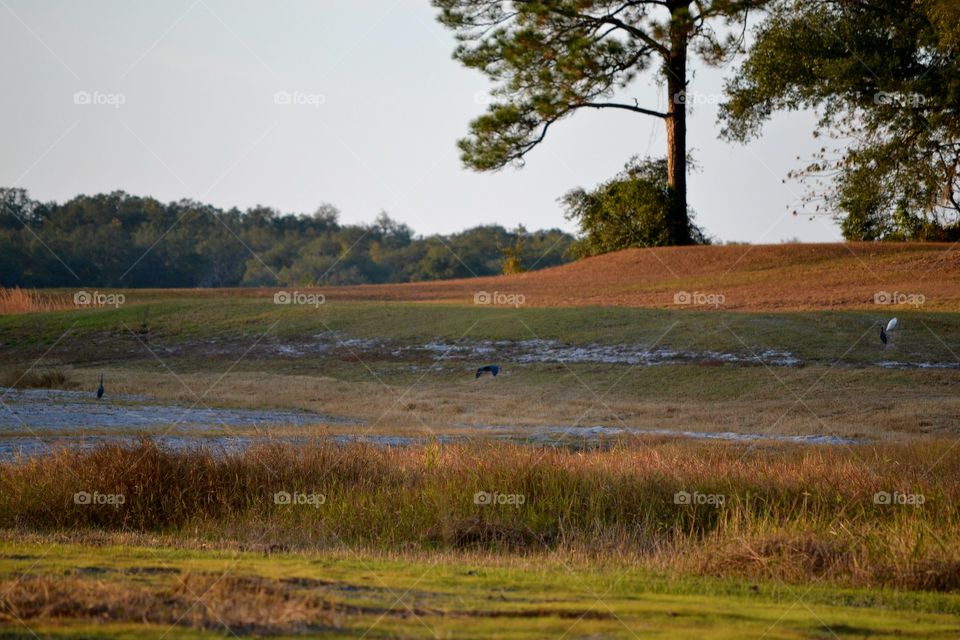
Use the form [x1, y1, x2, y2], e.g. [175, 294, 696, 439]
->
[560, 158, 708, 257]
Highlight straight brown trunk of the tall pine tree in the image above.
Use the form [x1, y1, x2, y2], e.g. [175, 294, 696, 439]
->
[664, 3, 692, 244]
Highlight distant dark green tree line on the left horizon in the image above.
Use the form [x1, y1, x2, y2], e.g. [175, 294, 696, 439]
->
[0, 188, 575, 287]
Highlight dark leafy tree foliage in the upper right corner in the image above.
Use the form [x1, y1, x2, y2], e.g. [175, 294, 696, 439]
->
[721, 0, 960, 240]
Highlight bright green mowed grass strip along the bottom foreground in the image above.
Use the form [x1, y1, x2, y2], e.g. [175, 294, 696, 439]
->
[0, 537, 960, 640]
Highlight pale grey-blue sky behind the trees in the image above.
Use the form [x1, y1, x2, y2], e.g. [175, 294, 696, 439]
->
[0, 0, 840, 243]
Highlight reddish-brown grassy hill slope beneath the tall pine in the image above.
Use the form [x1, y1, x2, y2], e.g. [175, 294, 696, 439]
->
[324, 242, 960, 311]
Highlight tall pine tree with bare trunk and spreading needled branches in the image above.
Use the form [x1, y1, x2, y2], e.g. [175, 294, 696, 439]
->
[433, 0, 769, 244]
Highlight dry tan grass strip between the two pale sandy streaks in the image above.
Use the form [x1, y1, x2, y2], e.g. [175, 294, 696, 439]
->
[94, 367, 960, 439]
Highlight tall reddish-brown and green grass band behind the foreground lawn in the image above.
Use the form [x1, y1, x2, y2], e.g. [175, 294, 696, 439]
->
[0, 439, 960, 591]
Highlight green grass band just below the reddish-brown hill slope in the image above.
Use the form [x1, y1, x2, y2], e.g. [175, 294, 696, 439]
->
[0, 291, 960, 364]
